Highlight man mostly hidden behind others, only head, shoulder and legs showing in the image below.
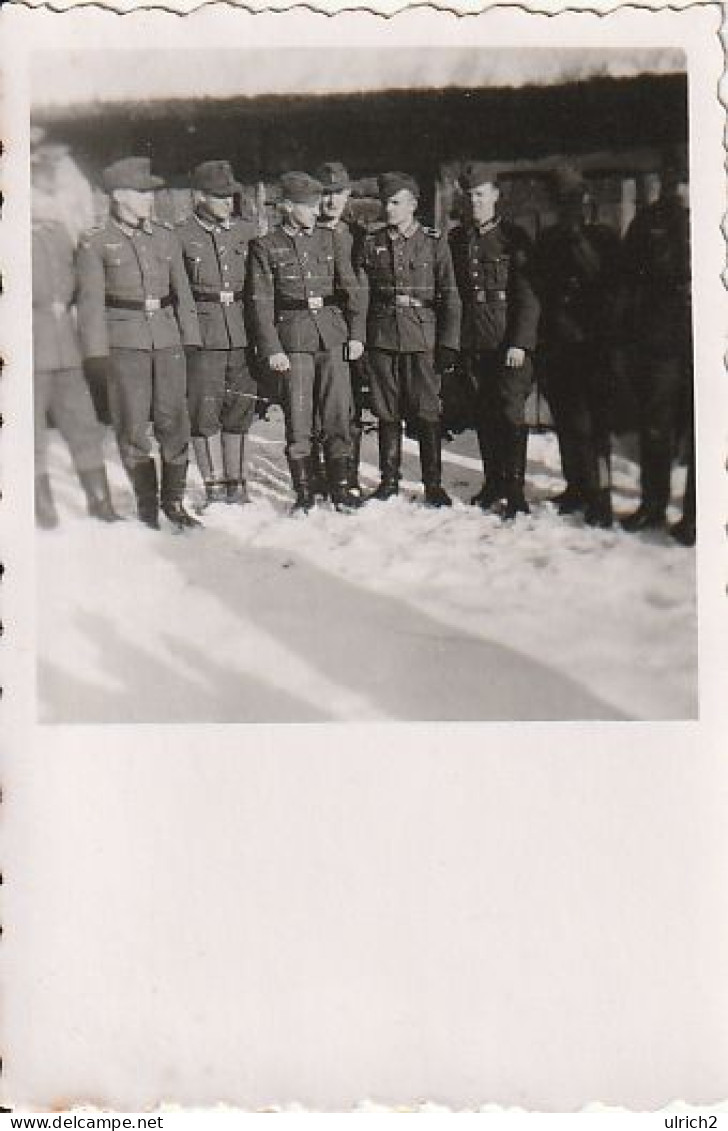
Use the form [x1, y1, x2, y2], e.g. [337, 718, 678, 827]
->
[312, 161, 365, 497]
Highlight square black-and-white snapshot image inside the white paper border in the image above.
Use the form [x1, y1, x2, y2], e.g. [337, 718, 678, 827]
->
[29, 28, 697, 723]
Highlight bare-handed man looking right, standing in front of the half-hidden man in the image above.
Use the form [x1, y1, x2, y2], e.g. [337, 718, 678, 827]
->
[246, 172, 365, 512]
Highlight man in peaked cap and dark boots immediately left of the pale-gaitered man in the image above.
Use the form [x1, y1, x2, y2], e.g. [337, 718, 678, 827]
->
[78, 157, 201, 529]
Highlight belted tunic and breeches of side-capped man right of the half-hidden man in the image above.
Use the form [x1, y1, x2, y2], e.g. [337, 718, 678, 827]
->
[356, 221, 461, 423]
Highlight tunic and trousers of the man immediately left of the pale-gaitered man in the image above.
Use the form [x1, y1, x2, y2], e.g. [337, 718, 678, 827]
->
[78, 218, 201, 470]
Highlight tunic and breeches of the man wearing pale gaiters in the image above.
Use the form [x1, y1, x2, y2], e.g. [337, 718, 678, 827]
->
[175, 214, 257, 437]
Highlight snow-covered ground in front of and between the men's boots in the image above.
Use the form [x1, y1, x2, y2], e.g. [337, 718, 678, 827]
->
[37, 411, 697, 723]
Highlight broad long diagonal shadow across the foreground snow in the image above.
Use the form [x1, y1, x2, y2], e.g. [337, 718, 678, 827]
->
[150, 519, 626, 722]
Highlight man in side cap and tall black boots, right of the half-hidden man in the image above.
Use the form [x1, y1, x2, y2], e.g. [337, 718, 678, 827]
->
[357, 173, 460, 507]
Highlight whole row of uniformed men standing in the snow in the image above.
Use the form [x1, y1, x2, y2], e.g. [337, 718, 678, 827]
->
[32, 139, 695, 545]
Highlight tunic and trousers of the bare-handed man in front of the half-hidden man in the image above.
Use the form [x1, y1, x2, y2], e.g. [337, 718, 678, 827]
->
[246, 224, 366, 459]
